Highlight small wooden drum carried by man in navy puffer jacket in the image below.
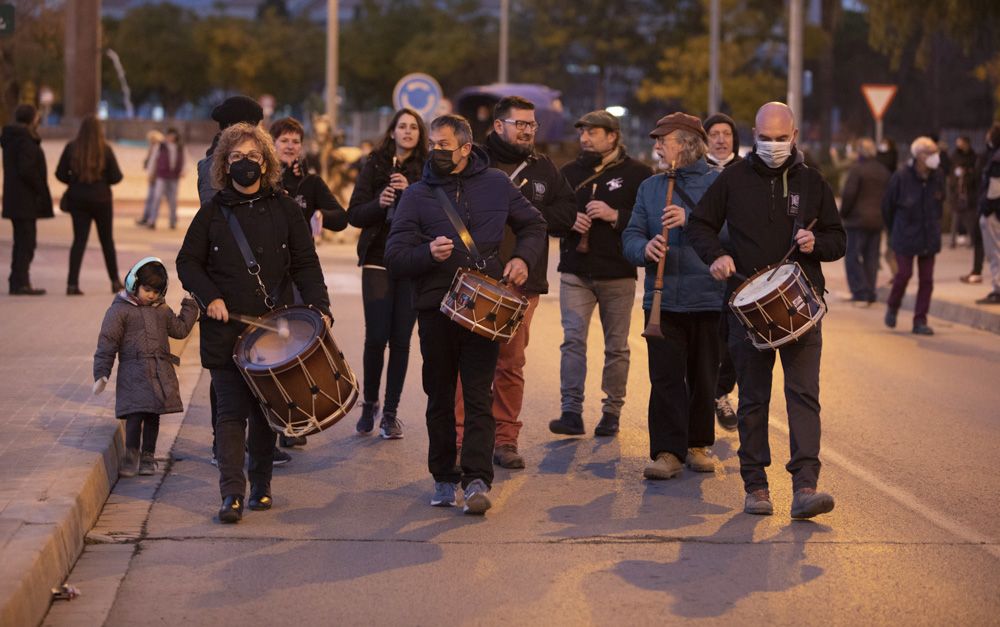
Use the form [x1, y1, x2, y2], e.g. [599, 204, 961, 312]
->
[441, 268, 528, 343]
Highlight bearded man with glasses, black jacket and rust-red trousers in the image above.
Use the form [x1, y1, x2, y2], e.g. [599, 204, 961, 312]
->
[455, 96, 576, 468]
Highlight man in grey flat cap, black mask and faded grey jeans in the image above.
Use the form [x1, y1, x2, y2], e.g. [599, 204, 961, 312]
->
[549, 111, 653, 436]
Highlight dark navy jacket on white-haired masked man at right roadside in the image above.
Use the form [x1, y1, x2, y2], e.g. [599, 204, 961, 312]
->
[882, 165, 944, 256]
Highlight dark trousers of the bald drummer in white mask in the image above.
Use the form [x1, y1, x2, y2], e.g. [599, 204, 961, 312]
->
[729, 314, 823, 493]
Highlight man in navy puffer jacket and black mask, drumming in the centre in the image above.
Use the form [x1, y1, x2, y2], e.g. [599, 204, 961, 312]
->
[385, 115, 546, 514]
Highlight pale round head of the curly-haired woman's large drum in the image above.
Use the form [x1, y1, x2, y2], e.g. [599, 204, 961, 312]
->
[235, 307, 323, 371]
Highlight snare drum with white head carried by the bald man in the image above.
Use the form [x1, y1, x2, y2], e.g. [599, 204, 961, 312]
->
[729, 263, 826, 350]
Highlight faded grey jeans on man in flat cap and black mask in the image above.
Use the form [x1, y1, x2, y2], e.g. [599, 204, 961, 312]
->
[559, 273, 635, 416]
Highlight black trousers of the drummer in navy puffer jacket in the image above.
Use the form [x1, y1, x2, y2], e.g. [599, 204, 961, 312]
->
[417, 310, 500, 488]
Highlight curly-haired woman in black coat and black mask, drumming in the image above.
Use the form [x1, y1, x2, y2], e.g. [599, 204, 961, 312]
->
[177, 123, 330, 523]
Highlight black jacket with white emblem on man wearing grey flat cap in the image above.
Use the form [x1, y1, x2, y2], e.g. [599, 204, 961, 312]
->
[559, 148, 653, 279]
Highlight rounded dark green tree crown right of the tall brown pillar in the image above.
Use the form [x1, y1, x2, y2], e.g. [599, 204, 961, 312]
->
[104, 3, 209, 115]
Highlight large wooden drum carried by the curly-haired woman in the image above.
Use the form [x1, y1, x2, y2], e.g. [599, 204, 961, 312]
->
[233, 305, 358, 437]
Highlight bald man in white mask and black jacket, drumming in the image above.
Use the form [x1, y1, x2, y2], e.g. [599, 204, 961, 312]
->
[687, 102, 847, 518]
